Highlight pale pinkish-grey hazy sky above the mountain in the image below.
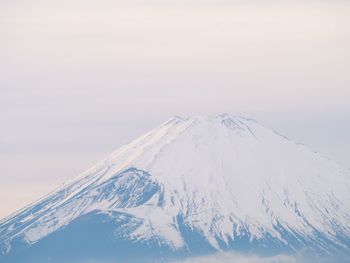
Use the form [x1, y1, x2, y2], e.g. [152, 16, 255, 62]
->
[0, 0, 350, 218]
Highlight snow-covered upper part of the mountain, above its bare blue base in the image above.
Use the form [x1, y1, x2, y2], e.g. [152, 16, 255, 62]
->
[0, 114, 350, 262]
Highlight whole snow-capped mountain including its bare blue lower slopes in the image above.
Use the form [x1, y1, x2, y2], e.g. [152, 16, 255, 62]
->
[0, 115, 350, 262]
